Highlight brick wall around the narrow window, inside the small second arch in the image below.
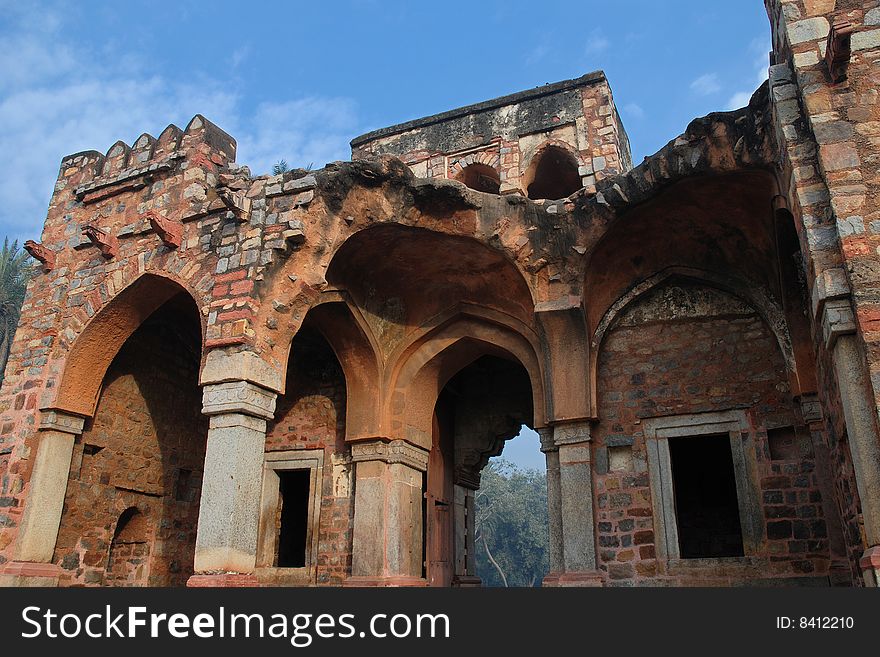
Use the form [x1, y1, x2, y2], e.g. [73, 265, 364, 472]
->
[266, 328, 353, 585]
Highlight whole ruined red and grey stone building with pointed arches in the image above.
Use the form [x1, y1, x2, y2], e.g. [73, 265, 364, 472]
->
[0, 0, 880, 586]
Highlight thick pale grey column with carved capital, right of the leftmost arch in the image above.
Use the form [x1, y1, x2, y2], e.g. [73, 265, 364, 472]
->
[188, 381, 275, 586]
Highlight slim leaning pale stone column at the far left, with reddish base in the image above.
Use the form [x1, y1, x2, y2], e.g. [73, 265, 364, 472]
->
[0, 410, 85, 586]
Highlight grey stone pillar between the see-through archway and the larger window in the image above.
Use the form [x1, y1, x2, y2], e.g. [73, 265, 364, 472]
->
[553, 422, 602, 586]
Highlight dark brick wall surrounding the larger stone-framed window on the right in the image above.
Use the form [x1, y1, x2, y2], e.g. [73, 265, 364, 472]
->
[594, 284, 829, 584]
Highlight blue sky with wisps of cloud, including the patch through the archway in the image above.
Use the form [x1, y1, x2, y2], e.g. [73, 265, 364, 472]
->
[0, 0, 770, 466]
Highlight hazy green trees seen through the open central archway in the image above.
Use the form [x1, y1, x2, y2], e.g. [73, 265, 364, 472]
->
[474, 460, 549, 586]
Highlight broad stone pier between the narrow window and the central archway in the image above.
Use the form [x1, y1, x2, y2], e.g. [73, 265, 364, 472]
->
[345, 439, 428, 586]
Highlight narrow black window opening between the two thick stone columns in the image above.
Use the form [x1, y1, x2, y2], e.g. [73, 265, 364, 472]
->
[275, 470, 311, 568]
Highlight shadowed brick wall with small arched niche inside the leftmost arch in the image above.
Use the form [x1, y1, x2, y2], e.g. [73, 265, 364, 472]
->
[55, 300, 207, 586]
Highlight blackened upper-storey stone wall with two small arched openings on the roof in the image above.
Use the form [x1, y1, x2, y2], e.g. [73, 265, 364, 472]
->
[352, 72, 632, 195]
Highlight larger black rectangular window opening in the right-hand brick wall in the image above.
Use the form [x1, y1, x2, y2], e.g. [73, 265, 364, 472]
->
[669, 434, 744, 559]
